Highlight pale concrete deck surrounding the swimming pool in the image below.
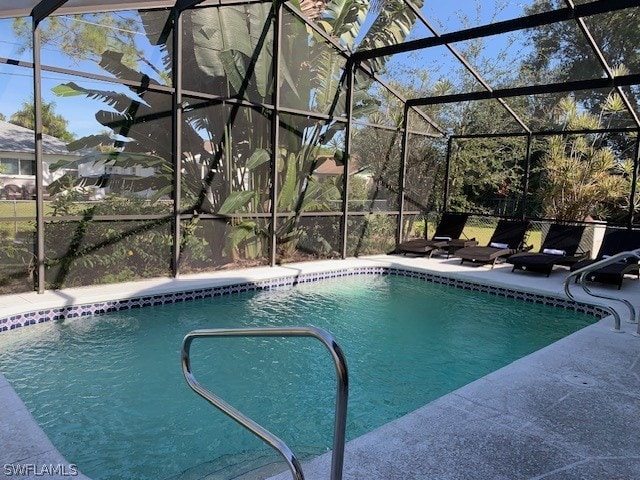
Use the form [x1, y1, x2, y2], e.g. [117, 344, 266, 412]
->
[0, 255, 640, 480]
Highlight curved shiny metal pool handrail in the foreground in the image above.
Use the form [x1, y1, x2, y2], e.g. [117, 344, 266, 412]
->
[181, 327, 349, 480]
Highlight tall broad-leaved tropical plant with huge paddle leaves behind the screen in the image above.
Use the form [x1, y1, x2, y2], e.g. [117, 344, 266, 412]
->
[21, 0, 424, 266]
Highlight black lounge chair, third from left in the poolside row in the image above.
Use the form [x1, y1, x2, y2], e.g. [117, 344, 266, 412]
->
[507, 223, 588, 277]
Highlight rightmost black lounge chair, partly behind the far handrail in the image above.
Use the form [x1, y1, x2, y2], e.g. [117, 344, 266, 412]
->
[571, 228, 640, 290]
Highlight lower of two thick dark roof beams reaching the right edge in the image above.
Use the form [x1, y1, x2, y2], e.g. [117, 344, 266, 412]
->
[407, 73, 640, 106]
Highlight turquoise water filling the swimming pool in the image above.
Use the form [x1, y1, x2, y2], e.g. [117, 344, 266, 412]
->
[0, 276, 595, 480]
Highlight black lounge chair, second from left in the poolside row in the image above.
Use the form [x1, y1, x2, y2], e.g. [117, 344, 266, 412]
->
[454, 219, 529, 268]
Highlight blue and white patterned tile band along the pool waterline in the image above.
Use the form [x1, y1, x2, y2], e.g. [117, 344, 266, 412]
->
[0, 266, 610, 332]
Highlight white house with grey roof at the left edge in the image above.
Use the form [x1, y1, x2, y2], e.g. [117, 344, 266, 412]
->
[0, 120, 86, 199]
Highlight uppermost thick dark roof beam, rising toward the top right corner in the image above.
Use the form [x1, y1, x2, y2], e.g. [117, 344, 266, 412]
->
[353, 0, 640, 60]
